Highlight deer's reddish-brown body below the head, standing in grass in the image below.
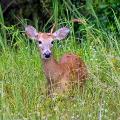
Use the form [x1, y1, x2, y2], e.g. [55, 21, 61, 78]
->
[43, 54, 87, 93]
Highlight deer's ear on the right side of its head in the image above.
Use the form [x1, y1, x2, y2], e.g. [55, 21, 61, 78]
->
[53, 27, 70, 40]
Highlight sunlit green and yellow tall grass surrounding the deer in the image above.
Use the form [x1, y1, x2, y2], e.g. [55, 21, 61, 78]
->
[0, 1, 120, 120]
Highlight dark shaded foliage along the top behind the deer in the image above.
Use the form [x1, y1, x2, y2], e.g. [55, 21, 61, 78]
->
[1, 0, 120, 46]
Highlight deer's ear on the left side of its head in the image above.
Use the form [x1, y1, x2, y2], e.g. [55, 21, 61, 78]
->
[25, 25, 38, 39]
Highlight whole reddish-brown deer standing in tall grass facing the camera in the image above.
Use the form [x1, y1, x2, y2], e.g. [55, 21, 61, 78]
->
[25, 26, 87, 93]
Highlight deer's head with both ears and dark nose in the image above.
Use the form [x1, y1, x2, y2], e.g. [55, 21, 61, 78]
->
[25, 25, 70, 59]
